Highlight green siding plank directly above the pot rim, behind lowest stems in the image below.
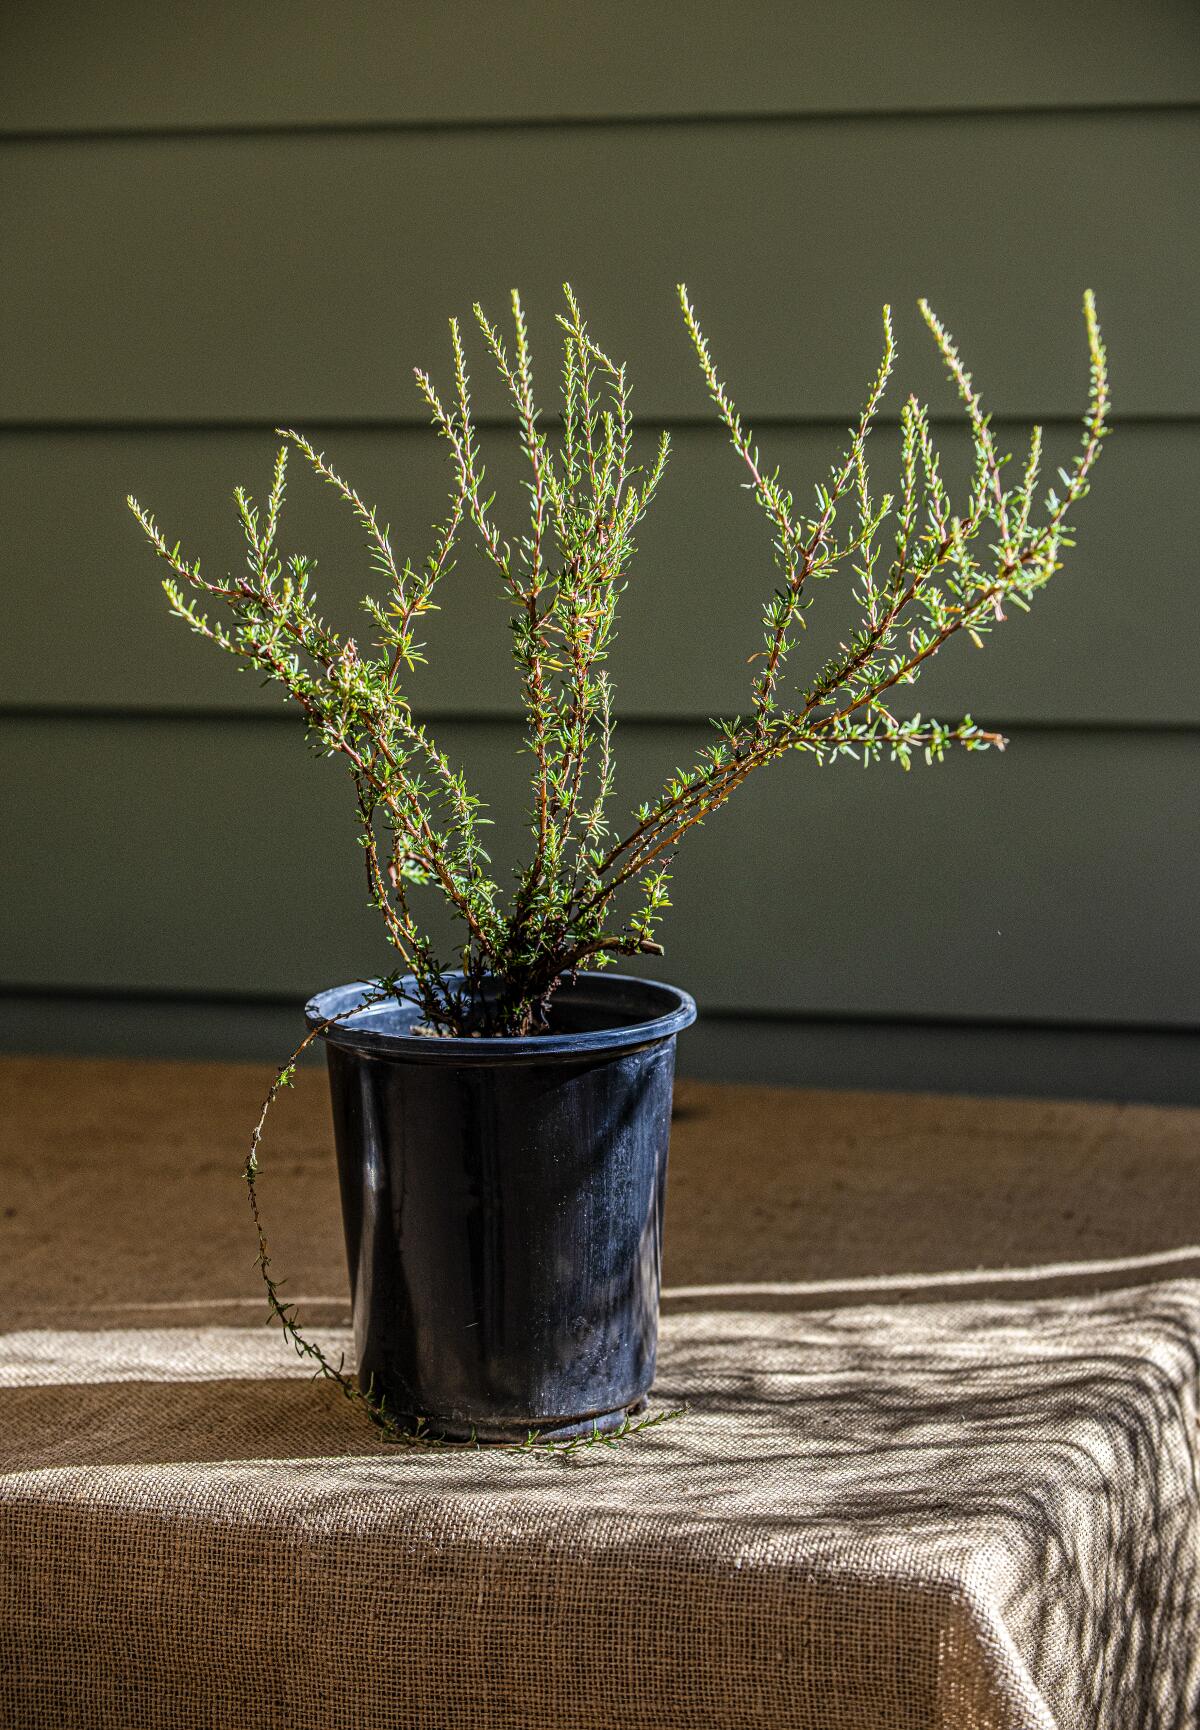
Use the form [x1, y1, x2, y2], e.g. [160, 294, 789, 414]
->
[0, 720, 1200, 1026]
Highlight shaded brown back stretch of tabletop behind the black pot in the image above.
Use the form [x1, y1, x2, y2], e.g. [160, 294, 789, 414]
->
[0, 1057, 1200, 1325]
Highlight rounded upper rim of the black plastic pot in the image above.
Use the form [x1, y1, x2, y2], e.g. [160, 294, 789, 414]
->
[304, 971, 697, 1064]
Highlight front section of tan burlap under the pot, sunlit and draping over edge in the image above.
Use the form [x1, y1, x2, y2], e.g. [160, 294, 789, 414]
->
[0, 1282, 1200, 1730]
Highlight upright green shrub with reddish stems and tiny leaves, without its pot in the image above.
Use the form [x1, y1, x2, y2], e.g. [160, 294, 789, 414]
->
[130, 287, 1108, 1035]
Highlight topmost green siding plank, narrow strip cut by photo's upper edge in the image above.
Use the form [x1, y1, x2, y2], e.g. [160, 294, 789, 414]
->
[0, 0, 1200, 131]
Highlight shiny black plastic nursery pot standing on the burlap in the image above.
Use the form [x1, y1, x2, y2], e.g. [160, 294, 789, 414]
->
[306, 972, 695, 1441]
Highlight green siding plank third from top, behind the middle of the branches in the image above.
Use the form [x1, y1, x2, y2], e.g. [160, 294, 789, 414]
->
[0, 426, 1200, 725]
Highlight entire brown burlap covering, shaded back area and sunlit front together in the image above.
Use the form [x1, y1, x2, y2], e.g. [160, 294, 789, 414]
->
[0, 1064, 1200, 1730]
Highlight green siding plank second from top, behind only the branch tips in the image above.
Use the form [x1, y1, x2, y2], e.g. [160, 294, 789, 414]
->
[0, 112, 1200, 422]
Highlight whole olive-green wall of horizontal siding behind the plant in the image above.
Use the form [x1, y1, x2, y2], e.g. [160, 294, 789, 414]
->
[0, 0, 1200, 1099]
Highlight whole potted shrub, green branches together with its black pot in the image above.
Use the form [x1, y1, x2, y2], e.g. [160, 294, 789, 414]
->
[130, 287, 1108, 1441]
